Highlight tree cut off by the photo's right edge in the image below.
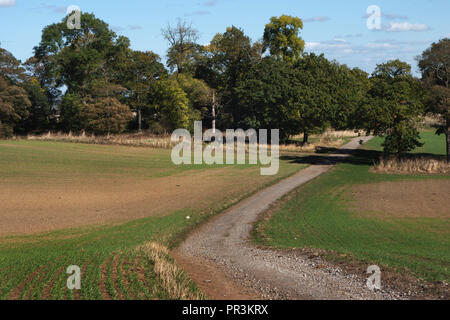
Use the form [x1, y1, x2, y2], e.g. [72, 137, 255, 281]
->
[418, 38, 450, 162]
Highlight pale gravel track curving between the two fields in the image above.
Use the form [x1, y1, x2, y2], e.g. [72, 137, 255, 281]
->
[173, 138, 404, 299]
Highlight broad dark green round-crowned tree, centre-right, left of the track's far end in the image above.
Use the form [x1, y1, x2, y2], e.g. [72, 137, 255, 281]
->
[235, 54, 356, 144]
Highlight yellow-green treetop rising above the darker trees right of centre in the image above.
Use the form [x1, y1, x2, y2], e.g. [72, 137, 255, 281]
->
[264, 15, 305, 62]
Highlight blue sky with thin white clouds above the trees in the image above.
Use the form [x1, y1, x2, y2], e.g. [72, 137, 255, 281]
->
[0, 0, 450, 72]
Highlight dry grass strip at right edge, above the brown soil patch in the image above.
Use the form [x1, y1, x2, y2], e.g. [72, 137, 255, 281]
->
[373, 157, 450, 174]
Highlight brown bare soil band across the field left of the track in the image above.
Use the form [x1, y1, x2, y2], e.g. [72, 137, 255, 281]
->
[0, 169, 278, 235]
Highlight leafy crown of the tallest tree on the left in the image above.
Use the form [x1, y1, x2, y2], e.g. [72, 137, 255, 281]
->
[34, 13, 129, 98]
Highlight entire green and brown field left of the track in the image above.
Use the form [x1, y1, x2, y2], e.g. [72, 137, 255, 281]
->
[0, 141, 304, 299]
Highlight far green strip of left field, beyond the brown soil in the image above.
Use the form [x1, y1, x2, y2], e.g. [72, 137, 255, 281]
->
[0, 140, 284, 179]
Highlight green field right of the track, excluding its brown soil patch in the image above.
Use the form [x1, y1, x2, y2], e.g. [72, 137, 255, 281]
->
[255, 132, 450, 281]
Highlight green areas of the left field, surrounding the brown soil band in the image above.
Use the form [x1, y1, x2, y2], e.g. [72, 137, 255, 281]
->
[0, 141, 303, 299]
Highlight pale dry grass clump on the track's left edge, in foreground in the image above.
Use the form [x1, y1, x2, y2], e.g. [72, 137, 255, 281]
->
[135, 242, 205, 300]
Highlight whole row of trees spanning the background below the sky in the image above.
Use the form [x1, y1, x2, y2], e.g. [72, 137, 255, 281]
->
[0, 13, 450, 160]
